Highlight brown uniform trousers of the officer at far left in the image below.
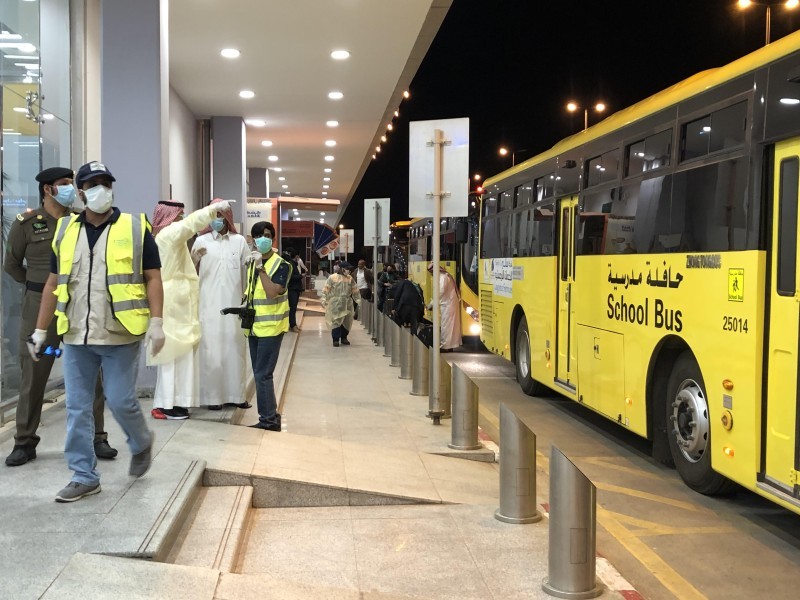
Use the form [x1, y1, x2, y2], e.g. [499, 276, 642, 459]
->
[14, 290, 108, 448]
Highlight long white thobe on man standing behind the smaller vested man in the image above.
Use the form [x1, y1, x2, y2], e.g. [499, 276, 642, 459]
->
[192, 231, 250, 405]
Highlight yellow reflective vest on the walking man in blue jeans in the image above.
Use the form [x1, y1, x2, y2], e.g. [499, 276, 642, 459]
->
[53, 213, 150, 336]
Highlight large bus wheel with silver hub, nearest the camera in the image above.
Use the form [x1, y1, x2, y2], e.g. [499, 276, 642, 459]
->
[665, 350, 735, 496]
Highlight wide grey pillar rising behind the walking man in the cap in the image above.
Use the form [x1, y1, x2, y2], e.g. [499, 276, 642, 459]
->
[100, 0, 169, 215]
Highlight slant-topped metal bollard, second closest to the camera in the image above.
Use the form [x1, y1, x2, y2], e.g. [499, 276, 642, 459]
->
[494, 403, 542, 523]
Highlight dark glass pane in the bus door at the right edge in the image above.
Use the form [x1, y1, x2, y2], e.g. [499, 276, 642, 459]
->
[778, 158, 798, 296]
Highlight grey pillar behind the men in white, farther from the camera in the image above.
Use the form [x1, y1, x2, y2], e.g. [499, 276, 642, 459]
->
[211, 117, 247, 224]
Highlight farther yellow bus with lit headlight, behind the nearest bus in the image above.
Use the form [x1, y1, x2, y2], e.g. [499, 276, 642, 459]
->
[408, 218, 481, 345]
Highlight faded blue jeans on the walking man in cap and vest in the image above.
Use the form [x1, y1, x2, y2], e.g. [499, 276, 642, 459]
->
[63, 342, 152, 485]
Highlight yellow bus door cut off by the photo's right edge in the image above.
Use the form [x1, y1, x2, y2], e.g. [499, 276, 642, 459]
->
[763, 138, 800, 496]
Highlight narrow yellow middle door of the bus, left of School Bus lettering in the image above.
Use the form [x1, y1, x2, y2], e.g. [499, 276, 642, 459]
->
[556, 196, 578, 390]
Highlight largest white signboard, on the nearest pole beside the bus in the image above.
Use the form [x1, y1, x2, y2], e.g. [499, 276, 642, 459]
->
[408, 117, 469, 218]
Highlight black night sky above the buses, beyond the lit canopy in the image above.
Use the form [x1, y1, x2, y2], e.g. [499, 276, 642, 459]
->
[342, 0, 800, 257]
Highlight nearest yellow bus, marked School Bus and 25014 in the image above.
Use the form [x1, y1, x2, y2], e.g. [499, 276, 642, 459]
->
[478, 32, 800, 512]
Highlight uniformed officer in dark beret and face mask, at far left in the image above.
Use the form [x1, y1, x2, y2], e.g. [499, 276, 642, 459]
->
[4, 167, 117, 467]
